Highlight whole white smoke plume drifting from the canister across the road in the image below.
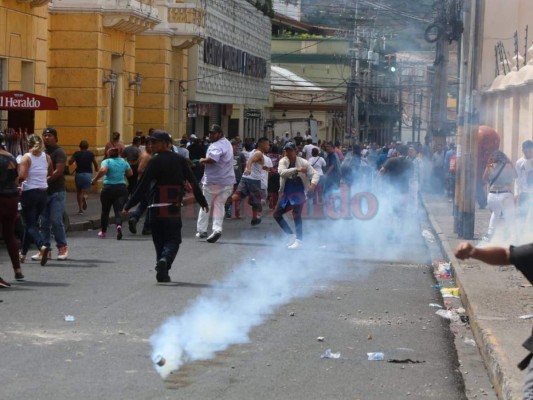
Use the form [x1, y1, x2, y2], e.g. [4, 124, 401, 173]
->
[150, 180, 428, 378]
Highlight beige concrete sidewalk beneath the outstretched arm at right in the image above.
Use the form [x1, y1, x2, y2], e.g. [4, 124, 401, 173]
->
[423, 195, 533, 400]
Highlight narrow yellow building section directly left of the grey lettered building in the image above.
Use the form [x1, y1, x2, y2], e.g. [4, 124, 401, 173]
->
[135, 1, 206, 137]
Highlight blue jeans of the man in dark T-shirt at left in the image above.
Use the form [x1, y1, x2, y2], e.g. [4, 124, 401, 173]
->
[41, 192, 67, 249]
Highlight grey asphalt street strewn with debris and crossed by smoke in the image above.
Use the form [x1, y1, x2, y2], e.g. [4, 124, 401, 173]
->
[0, 209, 465, 400]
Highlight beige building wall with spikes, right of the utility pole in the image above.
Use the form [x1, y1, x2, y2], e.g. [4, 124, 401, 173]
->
[477, 0, 533, 161]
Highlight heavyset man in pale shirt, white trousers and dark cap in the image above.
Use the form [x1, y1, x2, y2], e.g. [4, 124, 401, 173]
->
[196, 124, 235, 243]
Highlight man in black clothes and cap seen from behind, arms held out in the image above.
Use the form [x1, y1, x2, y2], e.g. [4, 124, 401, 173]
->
[123, 130, 209, 282]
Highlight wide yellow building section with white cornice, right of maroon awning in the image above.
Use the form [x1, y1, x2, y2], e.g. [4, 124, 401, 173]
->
[48, 0, 160, 153]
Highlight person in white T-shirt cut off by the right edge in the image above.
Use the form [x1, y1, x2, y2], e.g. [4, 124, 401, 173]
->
[515, 140, 533, 220]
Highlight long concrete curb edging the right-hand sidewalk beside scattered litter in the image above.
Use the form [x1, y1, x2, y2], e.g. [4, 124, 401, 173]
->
[422, 199, 522, 400]
